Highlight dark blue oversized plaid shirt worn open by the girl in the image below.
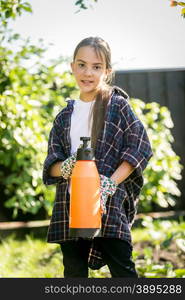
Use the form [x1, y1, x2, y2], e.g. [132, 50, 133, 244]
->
[43, 87, 153, 269]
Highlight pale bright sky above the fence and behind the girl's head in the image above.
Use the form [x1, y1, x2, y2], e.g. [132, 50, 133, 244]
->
[10, 0, 185, 69]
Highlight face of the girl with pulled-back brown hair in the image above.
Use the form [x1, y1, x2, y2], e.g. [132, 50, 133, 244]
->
[71, 46, 111, 101]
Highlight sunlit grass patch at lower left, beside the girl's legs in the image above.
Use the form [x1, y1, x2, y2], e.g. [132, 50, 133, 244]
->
[0, 235, 63, 278]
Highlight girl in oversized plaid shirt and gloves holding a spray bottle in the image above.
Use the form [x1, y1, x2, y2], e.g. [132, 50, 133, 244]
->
[43, 37, 152, 277]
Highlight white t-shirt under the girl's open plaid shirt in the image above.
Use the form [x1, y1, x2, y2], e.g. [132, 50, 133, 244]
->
[70, 100, 95, 154]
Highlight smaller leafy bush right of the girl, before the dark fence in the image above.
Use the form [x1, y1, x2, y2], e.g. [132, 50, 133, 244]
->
[131, 99, 182, 212]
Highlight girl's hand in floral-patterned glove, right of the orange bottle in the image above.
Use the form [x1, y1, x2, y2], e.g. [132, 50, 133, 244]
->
[100, 175, 117, 214]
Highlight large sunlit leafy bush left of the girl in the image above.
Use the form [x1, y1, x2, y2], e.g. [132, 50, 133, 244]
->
[0, 37, 76, 217]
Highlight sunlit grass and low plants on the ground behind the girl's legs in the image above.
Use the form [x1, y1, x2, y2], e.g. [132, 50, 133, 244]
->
[0, 218, 185, 278]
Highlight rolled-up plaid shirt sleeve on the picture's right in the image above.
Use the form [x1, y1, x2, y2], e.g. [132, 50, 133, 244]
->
[120, 98, 153, 173]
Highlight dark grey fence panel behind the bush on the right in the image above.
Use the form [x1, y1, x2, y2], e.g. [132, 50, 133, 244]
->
[115, 68, 185, 208]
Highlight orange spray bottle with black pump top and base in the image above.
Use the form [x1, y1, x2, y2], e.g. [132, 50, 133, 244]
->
[69, 137, 101, 238]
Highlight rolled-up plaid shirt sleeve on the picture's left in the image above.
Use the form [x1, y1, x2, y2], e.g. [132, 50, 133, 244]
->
[42, 120, 66, 185]
